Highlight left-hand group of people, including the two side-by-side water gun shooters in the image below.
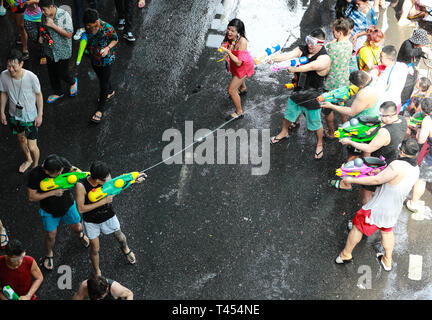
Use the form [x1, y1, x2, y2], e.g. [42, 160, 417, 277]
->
[0, 0, 150, 300]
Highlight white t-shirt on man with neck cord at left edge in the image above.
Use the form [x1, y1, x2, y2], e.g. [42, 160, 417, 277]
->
[0, 69, 41, 122]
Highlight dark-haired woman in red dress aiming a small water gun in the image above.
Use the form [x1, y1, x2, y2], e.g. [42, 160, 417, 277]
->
[219, 19, 254, 120]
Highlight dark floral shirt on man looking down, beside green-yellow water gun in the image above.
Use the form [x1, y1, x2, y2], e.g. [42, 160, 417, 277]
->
[87, 19, 118, 67]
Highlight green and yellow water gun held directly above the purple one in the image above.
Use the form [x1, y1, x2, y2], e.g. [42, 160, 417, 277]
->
[334, 116, 381, 142]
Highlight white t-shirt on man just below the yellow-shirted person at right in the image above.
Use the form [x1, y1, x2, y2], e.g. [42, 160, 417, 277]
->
[378, 62, 408, 107]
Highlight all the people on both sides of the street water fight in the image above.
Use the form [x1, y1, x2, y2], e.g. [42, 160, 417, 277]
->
[0, 0, 432, 299]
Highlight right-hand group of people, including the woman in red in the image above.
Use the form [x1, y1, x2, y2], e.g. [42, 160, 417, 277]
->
[220, 0, 432, 271]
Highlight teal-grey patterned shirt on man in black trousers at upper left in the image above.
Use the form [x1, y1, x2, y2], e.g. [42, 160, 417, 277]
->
[42, 8, 73, 62]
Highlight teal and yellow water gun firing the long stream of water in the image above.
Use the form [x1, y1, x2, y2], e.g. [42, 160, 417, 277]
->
[88, 171, 140, 202]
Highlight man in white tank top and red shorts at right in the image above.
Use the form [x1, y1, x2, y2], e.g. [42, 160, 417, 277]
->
[335, 138, 420, 271]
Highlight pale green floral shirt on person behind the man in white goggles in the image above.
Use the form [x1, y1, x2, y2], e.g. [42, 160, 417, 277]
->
[324, 40, 352, 91]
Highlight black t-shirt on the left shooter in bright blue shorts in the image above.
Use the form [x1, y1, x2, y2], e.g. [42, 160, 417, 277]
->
[27, 158, 74, 217]
